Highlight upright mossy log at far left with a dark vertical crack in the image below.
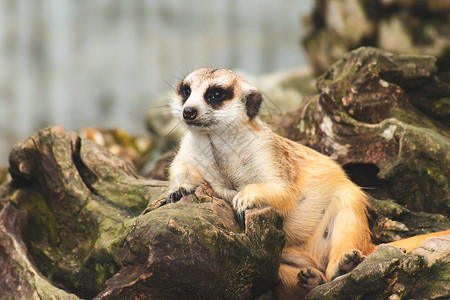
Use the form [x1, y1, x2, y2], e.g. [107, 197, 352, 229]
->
[2, 127, 165, 298]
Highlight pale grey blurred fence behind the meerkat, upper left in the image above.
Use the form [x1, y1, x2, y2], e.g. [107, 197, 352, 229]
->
[0, 0, 312, 164]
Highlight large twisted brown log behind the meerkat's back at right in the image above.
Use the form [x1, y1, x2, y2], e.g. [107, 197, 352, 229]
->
[274, 48, 450, 215]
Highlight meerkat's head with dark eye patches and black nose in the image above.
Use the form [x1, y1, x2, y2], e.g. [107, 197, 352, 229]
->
[172, 69, 262, 131]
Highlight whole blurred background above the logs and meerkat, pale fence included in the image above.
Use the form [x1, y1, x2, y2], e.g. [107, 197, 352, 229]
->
[0, 0, 450, 166]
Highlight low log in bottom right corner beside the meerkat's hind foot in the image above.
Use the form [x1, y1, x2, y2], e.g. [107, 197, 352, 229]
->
[306, 235, 450, 300]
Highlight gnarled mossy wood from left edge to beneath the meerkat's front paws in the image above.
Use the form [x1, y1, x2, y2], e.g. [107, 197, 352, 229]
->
[0, 127, 284, 299]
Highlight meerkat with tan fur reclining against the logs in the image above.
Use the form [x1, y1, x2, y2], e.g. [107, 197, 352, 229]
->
[167, 68, 374, 299]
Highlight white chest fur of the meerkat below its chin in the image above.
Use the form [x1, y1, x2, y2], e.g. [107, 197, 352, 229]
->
[179, 120, 271, 201]
